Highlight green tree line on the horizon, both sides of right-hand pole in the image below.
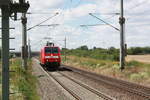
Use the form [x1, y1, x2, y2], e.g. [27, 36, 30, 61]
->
[62, 45, 150, 61]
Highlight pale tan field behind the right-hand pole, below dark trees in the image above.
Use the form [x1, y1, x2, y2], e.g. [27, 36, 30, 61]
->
[126, 55, 150, 64]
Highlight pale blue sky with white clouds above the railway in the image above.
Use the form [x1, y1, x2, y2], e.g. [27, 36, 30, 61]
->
[0, 0, 150, 51]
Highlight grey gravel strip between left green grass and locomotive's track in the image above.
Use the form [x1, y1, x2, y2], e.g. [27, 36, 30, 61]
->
[33, 59, 71, 100]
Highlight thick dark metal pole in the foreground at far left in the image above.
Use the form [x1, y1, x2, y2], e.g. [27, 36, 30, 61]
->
[2, 6, 9, 100]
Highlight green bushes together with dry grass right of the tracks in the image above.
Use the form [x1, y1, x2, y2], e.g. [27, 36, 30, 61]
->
[62, 45, 150, 86]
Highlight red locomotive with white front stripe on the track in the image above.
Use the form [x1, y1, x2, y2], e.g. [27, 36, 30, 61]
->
[40, 43, 61, 68]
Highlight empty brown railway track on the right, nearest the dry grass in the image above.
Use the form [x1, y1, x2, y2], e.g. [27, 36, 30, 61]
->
[64, 66, 150, 99]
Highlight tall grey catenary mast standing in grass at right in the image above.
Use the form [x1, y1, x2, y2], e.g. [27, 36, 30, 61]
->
[119, 0, 125, 70]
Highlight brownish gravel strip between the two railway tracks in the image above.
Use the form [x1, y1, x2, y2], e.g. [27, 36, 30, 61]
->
[59, 66, 145, 100]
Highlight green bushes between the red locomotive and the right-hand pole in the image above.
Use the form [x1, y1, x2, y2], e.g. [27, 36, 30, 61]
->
[62, 46, 119, 61]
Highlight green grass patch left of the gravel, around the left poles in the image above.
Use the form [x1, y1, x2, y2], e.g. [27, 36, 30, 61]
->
[0, 59, 40, 100]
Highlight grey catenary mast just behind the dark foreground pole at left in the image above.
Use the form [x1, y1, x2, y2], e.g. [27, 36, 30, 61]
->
[21, 13, 28, 69]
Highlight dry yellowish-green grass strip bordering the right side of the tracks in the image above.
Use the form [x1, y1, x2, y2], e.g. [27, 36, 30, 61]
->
[63, 55, 150, 86]
